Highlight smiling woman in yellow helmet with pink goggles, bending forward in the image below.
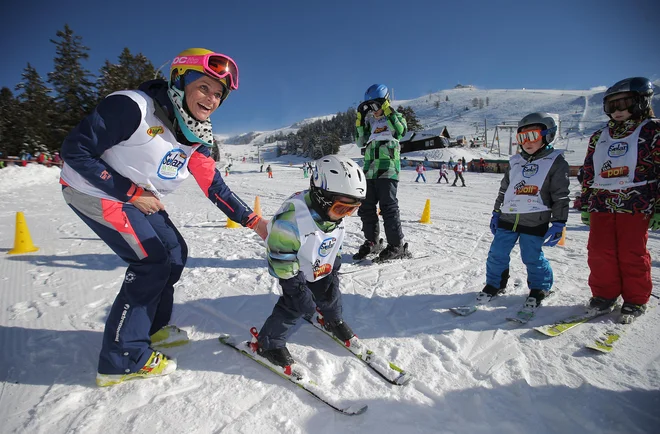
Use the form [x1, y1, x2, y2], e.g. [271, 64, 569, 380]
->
[60, 48, 267, 386]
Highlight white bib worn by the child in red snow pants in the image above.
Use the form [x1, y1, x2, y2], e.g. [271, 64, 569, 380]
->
[591, 119, 649, 190]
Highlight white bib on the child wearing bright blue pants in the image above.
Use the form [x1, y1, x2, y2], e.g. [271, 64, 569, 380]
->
[502, 150, 561, 214]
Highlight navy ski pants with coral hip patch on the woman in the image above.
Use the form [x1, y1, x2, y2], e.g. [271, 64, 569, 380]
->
[62, 187, 188, 374]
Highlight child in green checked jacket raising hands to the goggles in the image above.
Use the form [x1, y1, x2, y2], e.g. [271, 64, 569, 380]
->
[353, 84, 408, 260]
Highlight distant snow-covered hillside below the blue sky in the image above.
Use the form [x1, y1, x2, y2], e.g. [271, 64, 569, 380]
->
[221, 83, 660, 166]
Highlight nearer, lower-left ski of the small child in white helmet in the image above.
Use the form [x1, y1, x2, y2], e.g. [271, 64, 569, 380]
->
[218, 327, 368, 416]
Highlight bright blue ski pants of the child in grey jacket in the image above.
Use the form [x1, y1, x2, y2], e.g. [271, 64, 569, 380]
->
[486, 228, 553, 291]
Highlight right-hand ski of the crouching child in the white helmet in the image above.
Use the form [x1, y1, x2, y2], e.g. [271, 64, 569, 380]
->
[304, 312, 413, 386]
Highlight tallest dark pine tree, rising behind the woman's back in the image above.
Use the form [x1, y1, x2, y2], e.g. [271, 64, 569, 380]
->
[48, 24, 95, 142]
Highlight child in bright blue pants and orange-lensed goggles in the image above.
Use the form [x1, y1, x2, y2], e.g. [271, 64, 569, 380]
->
[477, 112, 569, 315]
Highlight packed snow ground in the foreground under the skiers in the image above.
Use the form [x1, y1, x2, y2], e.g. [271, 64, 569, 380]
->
[0, 161, 660, 434]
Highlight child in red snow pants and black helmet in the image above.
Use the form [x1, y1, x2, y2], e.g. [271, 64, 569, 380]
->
[580, 77, 660, 323]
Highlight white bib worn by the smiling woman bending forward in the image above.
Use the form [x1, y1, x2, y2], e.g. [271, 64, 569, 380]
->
[62, 90, 200, 200]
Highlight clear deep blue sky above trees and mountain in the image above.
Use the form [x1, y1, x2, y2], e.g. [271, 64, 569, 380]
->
[0, 0, 660, 134]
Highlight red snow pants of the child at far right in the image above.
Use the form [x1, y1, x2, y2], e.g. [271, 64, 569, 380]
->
[587, 212, 653, 304]
